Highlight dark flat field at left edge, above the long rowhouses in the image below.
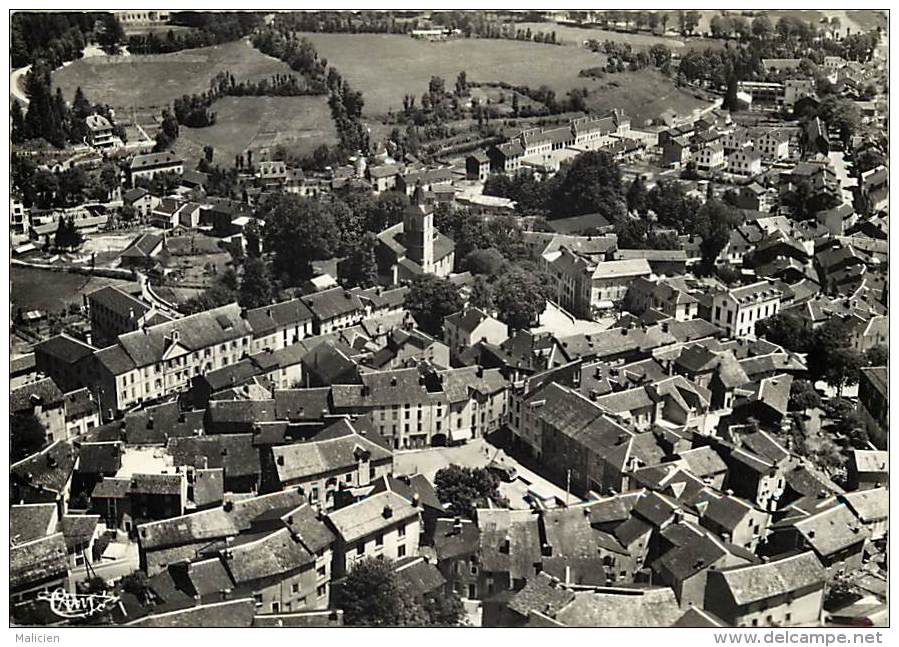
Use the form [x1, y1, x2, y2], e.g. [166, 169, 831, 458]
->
[9, 266, 136, 312]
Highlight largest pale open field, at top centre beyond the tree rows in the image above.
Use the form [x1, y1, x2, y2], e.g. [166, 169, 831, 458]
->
[303, 33, 605, 115]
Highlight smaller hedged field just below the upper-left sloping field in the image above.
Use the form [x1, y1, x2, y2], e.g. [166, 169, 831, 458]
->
[178, 97, 337, 164]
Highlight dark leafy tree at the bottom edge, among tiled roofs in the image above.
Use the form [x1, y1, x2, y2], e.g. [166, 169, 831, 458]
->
[335, 558, 425, 627]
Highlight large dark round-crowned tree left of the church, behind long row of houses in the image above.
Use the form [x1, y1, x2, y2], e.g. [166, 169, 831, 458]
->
[262, 193, 340, 285]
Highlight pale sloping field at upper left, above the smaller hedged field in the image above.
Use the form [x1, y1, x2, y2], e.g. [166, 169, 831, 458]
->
[53, 41, 290, 108]
